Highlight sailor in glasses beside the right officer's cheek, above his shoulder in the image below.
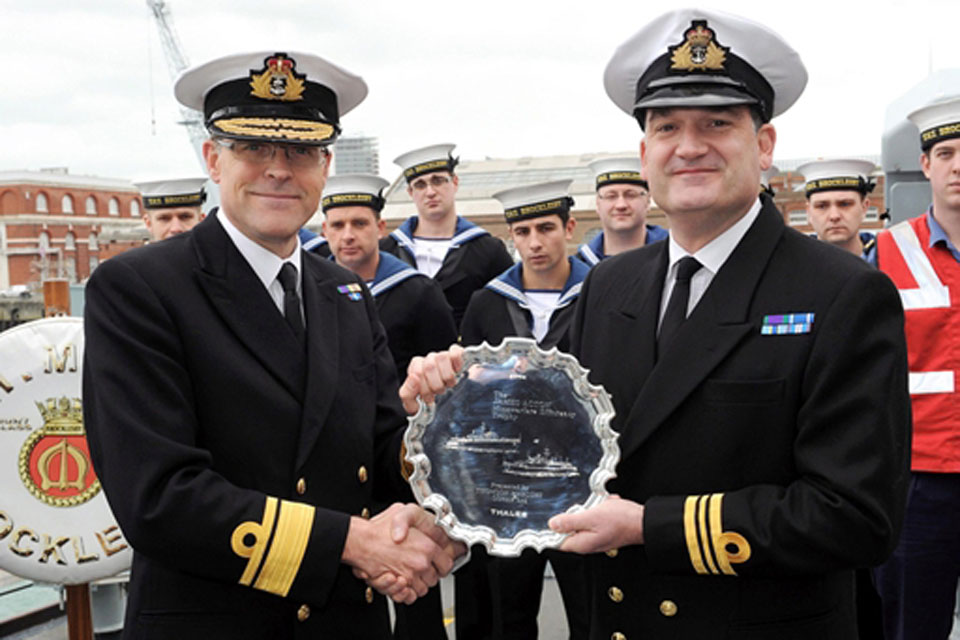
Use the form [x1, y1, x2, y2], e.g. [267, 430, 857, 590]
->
[577, 157, 667, 267]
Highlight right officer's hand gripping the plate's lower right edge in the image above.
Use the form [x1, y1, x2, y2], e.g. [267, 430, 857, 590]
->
[549, 495, 643, 553]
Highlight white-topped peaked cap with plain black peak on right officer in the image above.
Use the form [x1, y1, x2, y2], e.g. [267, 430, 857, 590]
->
[604, 9, 807, 127]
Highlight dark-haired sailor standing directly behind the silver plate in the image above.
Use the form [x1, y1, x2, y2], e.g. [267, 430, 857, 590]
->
[455, 180, 590, 638]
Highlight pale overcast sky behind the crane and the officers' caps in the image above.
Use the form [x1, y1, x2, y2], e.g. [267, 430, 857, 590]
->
[0, 0, 960, 179]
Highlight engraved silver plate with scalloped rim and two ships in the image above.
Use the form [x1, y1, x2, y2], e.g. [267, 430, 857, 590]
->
[404, 338, 620, 556]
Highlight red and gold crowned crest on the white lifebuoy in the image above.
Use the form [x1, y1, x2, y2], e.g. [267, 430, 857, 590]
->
[19, 396, 100, 507]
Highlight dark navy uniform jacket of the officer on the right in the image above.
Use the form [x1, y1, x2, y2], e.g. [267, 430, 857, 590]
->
[571, 197, 910, 640]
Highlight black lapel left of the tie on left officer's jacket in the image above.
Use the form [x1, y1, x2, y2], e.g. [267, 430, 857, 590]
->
[192, 211, 306, 401]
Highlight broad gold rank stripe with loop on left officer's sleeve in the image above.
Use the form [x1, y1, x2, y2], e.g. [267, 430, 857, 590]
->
[230, 497, 315, 596]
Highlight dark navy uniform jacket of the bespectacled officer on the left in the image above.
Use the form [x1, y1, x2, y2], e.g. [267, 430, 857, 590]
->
[83, 215, 412, 640]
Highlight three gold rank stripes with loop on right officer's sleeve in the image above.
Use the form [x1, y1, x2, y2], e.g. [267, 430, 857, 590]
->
[683, 493, 750, 576]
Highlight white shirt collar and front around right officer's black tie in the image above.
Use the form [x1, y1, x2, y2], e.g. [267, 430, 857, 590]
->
[658, 198, 760, 326]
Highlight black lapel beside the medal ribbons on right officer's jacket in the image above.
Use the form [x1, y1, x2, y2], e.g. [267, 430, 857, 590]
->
[620, 204, 783, 457]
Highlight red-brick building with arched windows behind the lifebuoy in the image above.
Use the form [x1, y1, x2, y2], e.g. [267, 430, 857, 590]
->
[0, 168, 147, 291]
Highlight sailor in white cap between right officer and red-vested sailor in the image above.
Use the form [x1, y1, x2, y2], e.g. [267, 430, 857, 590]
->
[797, 158, 876, 262]
